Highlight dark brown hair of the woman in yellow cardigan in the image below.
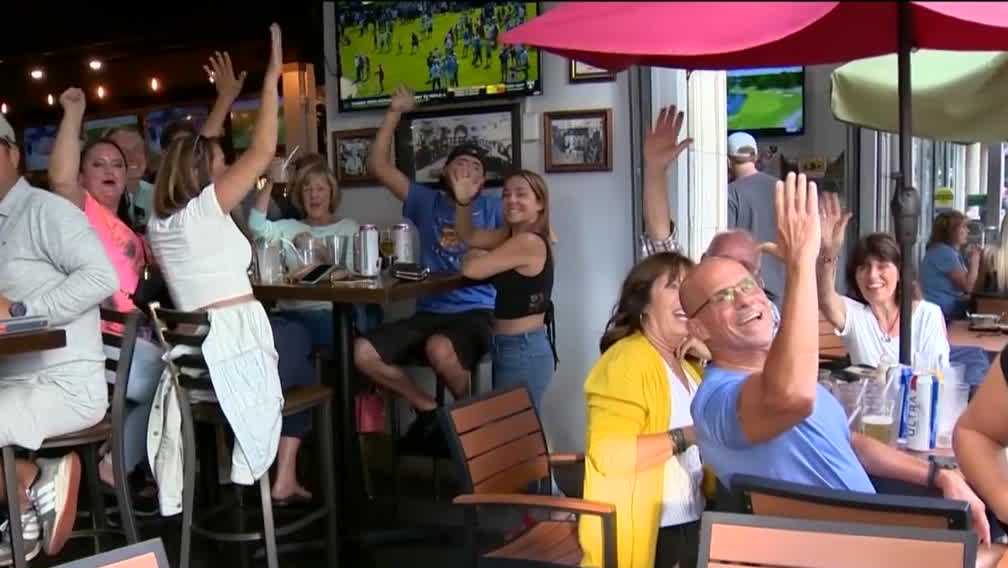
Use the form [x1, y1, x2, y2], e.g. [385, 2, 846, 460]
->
[599, 252, 694, 353]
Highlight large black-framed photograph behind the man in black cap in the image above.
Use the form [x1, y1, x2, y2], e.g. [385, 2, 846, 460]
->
[396, 104, 521, 187]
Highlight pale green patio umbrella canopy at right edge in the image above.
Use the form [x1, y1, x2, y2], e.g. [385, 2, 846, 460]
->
[831, 49, 1008, 142]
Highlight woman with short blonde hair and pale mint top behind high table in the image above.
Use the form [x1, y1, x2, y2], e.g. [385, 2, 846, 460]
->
[249, 154, 359, 347]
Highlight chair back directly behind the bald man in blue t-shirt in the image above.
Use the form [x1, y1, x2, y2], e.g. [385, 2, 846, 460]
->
[732, 475, 971, 531]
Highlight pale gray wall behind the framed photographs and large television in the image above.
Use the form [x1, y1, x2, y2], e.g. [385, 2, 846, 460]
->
[324, 2, 635, 451]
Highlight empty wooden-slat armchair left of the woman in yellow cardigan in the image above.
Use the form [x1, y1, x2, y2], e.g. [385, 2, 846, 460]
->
[439, 386, 618, 568]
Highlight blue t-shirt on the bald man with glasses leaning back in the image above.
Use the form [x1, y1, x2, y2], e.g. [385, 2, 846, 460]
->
[689, 364, 875, 493]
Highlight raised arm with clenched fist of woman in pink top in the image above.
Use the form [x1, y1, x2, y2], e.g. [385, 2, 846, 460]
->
[49, 87, 87, 209]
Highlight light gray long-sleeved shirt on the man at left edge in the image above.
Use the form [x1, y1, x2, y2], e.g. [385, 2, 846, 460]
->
[0, 178, 119, 381]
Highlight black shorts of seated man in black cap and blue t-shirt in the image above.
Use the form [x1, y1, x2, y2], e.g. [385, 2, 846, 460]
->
[365, 310, 494, 370]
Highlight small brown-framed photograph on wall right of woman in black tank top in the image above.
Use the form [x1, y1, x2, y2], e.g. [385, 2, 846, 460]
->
[542, 109, 613, 174]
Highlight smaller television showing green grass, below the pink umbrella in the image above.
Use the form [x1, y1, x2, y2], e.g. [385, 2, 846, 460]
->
[728, 67, 805, 135]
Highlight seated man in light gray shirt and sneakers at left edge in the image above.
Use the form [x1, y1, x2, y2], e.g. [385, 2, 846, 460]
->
[0, 115, 119, 565]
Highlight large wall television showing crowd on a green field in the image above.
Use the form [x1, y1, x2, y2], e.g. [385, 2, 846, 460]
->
[336, 1, 542, 111]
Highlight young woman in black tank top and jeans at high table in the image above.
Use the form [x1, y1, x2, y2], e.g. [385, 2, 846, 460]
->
[449, 169, 556, 408]
